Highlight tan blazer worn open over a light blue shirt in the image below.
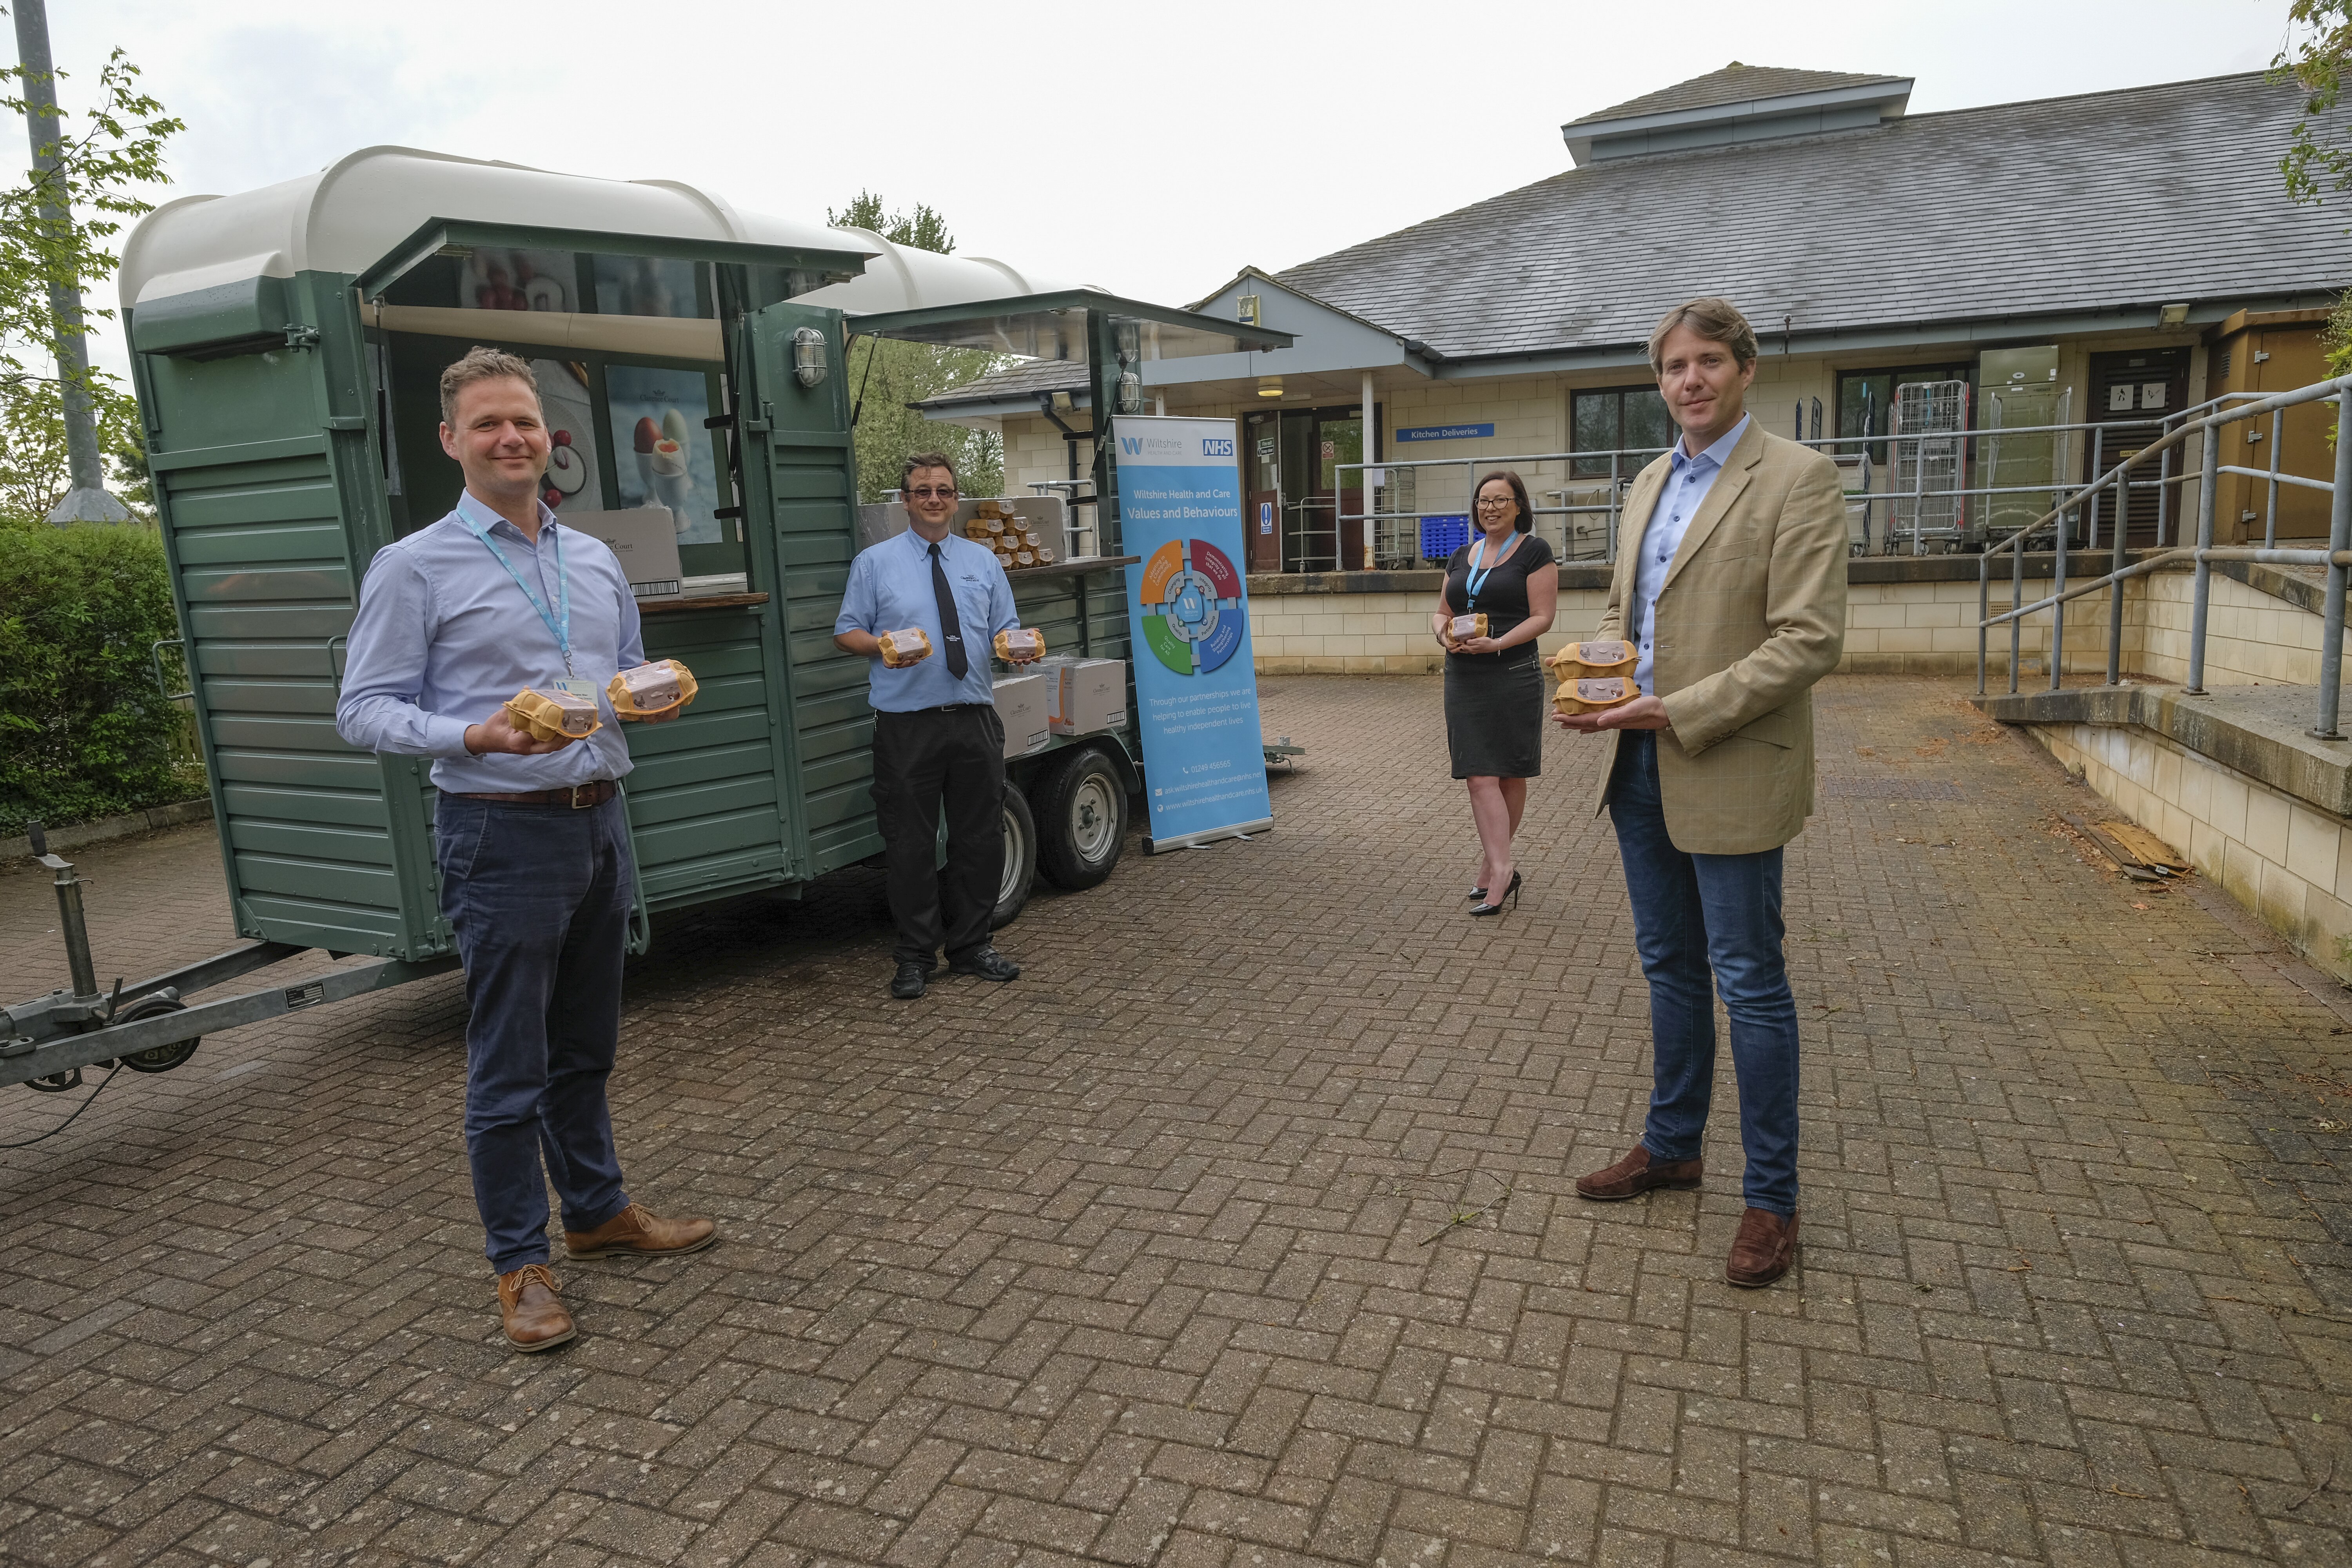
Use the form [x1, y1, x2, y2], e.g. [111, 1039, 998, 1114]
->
[1595, 421, 1846, 856]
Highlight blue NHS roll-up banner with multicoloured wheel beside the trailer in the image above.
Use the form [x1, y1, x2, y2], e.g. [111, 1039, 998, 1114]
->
[1110, 414, 1275, 853]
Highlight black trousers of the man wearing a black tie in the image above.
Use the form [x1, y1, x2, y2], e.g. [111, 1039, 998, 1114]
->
[873, 705, 1004, 964]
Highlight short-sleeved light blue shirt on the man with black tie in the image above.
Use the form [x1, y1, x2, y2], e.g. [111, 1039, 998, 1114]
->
[833, 529, 1021, 712]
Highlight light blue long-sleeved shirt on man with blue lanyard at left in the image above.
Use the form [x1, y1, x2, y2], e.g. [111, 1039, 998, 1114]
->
[334, 491, 644, 795]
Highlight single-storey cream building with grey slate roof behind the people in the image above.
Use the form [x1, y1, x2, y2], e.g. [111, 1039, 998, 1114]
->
[927, 64, 2352, 571]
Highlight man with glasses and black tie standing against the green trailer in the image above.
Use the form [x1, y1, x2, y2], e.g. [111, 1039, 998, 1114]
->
[833, 451, 1035, 1002]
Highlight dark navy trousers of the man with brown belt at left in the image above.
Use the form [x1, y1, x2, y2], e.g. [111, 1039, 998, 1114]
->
[433, 792, 637, 1274]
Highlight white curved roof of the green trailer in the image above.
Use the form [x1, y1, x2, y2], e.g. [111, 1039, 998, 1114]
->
[118, 146, 1073, 315]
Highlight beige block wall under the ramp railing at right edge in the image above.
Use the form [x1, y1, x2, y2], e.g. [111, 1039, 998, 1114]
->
[2030, 724, 2352, 980]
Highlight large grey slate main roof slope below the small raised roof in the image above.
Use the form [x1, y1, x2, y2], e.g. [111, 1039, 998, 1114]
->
[1279, 73, 2352, 369]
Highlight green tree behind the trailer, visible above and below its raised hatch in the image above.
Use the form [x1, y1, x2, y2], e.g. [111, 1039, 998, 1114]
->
[826, 191, 1011, 501]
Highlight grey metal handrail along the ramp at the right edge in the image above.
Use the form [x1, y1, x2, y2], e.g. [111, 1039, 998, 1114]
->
[1976, 376, 2352, 740]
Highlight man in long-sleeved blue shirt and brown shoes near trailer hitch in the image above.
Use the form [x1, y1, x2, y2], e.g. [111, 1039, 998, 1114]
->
[334, 348, 715, 1352]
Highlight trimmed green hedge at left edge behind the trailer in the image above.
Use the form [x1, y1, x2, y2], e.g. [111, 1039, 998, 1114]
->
[0, 522, 205, 837]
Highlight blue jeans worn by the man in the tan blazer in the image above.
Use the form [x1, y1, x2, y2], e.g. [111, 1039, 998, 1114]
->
[1609, 731, 1797, 1218]
